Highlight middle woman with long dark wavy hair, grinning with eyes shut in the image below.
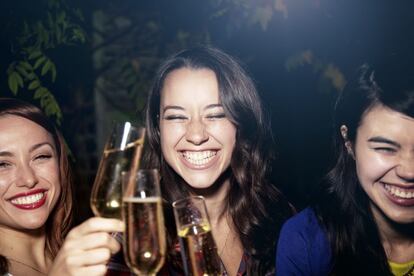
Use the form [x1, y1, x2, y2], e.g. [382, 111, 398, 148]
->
[107, 47, 293, 275]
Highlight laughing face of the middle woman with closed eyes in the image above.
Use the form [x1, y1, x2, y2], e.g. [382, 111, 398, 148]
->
[160, 68, 236, 189]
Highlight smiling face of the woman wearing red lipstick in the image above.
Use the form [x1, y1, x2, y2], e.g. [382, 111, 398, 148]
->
[0, 115, 61, 230]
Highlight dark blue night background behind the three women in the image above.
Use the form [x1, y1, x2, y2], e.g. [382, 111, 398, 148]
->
[0, 0, 414, 221]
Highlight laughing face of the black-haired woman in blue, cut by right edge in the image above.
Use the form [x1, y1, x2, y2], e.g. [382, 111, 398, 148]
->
[354, 105, 414, 223]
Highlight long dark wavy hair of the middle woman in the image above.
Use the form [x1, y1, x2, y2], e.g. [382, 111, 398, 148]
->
[146, 46, 292, 275]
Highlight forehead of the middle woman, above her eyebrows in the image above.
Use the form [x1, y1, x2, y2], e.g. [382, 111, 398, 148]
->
[161, 68, 220, 107]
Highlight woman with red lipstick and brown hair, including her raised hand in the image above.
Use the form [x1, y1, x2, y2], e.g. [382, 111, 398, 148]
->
[0, 98, 123, 276]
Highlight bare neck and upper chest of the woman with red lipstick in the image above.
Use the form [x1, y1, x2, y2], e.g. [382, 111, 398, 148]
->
[0, 226, 50, 271]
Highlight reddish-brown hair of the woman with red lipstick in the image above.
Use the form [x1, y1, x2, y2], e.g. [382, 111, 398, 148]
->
[0, 98, 72, 274]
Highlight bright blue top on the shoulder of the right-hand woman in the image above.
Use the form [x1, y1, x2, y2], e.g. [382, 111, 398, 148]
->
[276, 208, 332, 276]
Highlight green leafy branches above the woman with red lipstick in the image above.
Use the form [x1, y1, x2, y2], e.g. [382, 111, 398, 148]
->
[7, 0, 86, 124]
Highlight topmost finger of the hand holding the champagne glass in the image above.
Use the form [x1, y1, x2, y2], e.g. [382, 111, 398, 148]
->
[68, 217, 125, 238]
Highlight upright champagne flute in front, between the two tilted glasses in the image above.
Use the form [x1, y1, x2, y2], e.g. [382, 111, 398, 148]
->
[122, 170, 166, 275]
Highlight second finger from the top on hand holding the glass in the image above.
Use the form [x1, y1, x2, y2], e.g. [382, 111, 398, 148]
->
[63, 232, 121, 254]
